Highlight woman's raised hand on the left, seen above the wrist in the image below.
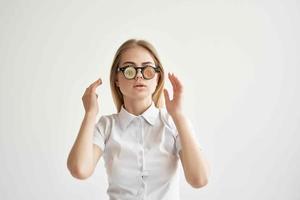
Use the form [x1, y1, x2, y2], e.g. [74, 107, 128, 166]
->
[82, 78, 102, 115]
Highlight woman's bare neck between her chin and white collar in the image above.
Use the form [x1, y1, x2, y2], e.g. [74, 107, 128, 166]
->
[124, 97, 152, 116]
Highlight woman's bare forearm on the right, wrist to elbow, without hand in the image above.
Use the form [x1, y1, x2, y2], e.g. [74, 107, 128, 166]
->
[172, 114, 209, 187]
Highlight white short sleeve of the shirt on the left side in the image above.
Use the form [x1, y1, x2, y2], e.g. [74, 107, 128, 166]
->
[93, 116, 109, 151]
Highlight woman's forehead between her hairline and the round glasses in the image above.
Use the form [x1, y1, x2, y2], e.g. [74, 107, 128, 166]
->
[120, 46, 154, 64]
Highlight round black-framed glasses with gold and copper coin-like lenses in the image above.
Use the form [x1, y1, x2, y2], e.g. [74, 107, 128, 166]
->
[117, 65, 160, 80]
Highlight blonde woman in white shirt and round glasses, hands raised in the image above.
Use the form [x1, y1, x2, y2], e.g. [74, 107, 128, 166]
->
[67, 39, 209, 200]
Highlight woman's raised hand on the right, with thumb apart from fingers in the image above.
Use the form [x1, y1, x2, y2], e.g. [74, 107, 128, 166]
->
[164, 73, 183, 117]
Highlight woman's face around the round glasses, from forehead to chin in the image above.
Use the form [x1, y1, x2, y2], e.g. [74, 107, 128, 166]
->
[116, 46, 159, 100]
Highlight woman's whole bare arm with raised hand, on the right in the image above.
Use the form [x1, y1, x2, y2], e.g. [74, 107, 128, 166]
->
[164, 73, 210, 188]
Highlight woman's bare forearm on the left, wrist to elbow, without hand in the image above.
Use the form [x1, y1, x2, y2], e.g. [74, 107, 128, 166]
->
[67, 113, 96, 174]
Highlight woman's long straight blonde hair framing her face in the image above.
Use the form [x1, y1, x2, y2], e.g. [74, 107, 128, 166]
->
[110, 39, 165, 112]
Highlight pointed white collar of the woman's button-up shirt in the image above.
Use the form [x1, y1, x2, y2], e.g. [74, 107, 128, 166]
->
[118, 101, 159, 129]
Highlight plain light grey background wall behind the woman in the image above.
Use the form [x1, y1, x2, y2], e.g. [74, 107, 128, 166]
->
[0, 0, 300, 200]
